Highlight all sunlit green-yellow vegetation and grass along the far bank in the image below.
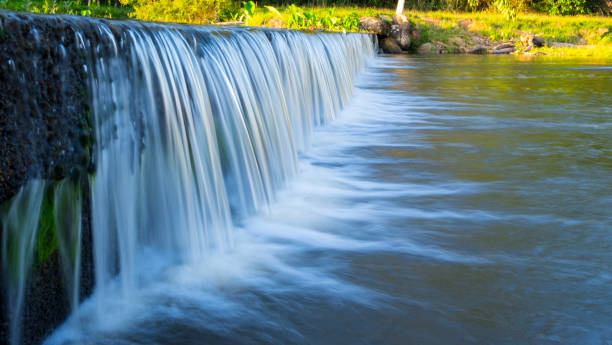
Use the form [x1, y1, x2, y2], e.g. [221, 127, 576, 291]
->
[0, 0, 612, 56]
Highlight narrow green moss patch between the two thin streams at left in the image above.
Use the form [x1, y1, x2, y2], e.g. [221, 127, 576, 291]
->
[36, 184, 57, 264]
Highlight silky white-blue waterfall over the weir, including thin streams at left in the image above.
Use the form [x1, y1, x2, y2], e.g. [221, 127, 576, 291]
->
[3, 17, 375, 343]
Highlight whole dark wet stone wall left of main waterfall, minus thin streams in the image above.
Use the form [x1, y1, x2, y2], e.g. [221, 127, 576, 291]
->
[0, 11, 93, 344]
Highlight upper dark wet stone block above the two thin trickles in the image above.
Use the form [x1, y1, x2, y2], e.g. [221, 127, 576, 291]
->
[0, 12, 92, 203]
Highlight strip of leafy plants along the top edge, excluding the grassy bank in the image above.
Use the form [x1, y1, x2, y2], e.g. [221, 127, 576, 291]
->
[0, 0, 612, 24]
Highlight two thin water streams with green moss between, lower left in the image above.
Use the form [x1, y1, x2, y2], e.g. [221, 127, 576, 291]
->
[1, 179, 82, 344]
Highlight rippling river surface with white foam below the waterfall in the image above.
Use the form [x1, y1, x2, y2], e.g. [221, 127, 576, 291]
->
[47, 56, 612, 345]
